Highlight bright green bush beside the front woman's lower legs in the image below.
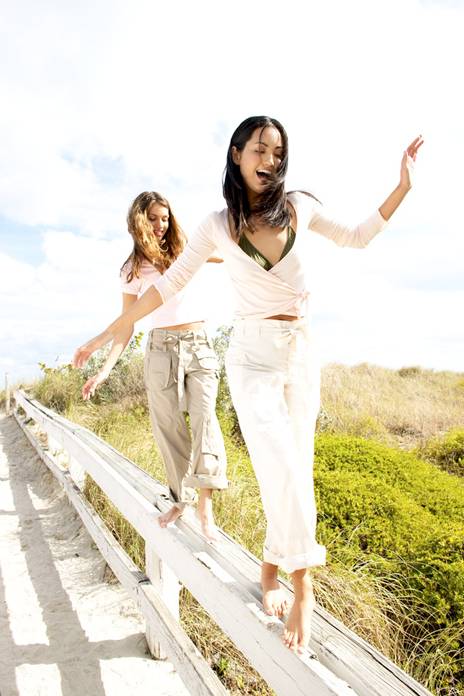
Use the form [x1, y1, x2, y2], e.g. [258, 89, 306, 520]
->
[315, 434, 464, 679]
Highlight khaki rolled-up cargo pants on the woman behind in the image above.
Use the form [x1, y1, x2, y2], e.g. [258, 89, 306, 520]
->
[144, 329, 227, 508]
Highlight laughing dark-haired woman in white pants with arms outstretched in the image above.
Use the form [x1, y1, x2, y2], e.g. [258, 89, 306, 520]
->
[74, 116, 423, 650]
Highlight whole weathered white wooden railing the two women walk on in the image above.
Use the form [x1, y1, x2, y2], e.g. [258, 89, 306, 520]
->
[10, 391, 430, 696]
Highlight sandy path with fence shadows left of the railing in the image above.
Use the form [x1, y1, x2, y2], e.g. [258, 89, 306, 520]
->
[0, 416, 188, 696]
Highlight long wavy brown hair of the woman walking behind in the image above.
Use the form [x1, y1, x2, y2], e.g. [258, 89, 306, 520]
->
[121, 191, 187, 283]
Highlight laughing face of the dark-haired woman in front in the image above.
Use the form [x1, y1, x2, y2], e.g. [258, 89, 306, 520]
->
[232, 126, 283, 200]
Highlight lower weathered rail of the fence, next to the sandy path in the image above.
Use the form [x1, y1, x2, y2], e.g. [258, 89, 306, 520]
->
[15, 414, 228, 696]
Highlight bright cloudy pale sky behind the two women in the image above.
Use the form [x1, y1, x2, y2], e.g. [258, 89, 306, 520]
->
[0, 0, 464, 383]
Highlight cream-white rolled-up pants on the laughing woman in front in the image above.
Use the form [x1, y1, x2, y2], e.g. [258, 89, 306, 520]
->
[226, 319, 325, 573]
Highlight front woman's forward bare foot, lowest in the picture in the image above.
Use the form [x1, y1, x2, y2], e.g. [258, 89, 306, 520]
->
[282, 569, 315, 653]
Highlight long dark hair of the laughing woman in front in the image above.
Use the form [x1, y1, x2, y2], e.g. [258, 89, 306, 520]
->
[222, 116, 291, 238]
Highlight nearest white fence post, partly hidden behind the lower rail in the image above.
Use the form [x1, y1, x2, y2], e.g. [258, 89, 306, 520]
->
[145, 544, 181, 660]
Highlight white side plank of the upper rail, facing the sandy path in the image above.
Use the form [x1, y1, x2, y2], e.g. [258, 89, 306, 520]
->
[13, 395, 353, 696]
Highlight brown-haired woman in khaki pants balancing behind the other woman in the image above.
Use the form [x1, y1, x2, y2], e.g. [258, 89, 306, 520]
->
[82, 191, 227, 541]
